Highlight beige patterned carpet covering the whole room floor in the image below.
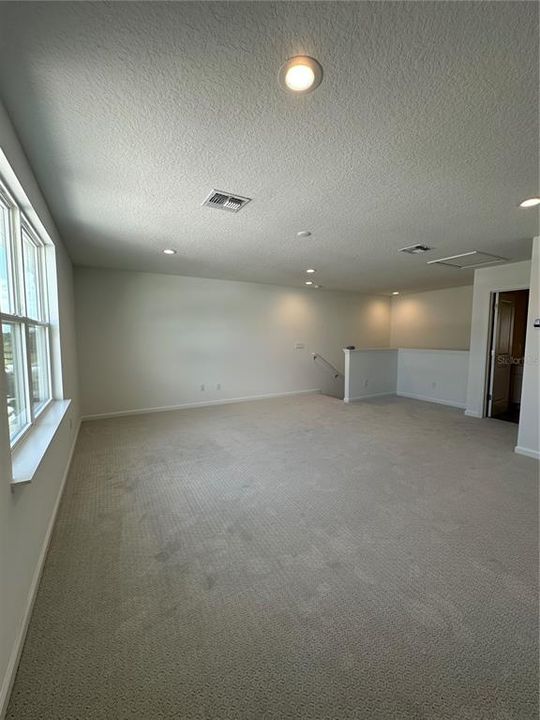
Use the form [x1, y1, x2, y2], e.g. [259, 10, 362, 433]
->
[7, 395, 538, 720]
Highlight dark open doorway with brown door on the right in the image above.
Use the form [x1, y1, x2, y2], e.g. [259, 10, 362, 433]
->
[486, 290, 529, 423]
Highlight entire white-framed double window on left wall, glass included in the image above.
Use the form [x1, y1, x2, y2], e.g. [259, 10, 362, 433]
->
[0, 185, 51, 446]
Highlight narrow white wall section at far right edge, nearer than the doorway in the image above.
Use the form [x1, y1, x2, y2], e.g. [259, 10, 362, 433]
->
[516, 237, 540, 459]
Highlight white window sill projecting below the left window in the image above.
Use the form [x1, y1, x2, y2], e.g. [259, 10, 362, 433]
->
[11, 400, 71, 486]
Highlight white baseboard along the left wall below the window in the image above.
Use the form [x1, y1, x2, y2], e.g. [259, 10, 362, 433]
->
[0, 421, 81, 720]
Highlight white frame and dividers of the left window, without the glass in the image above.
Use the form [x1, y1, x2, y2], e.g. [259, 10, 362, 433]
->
[0, 179, 53, 451]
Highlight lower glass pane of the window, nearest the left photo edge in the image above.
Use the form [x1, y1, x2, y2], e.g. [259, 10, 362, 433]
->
[2, 323, 28, 442]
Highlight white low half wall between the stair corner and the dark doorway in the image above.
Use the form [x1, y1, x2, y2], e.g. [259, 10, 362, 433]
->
[397, 348, 469, 408]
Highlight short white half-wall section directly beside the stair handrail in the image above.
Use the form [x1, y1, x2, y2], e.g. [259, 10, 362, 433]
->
[344, 349, 397, 402]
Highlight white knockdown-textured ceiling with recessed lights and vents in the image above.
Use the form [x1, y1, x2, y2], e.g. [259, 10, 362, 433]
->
[0, 2, 538, 292]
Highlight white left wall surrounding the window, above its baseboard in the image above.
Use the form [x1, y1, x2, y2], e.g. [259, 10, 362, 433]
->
[0, 104, 78, 716]
